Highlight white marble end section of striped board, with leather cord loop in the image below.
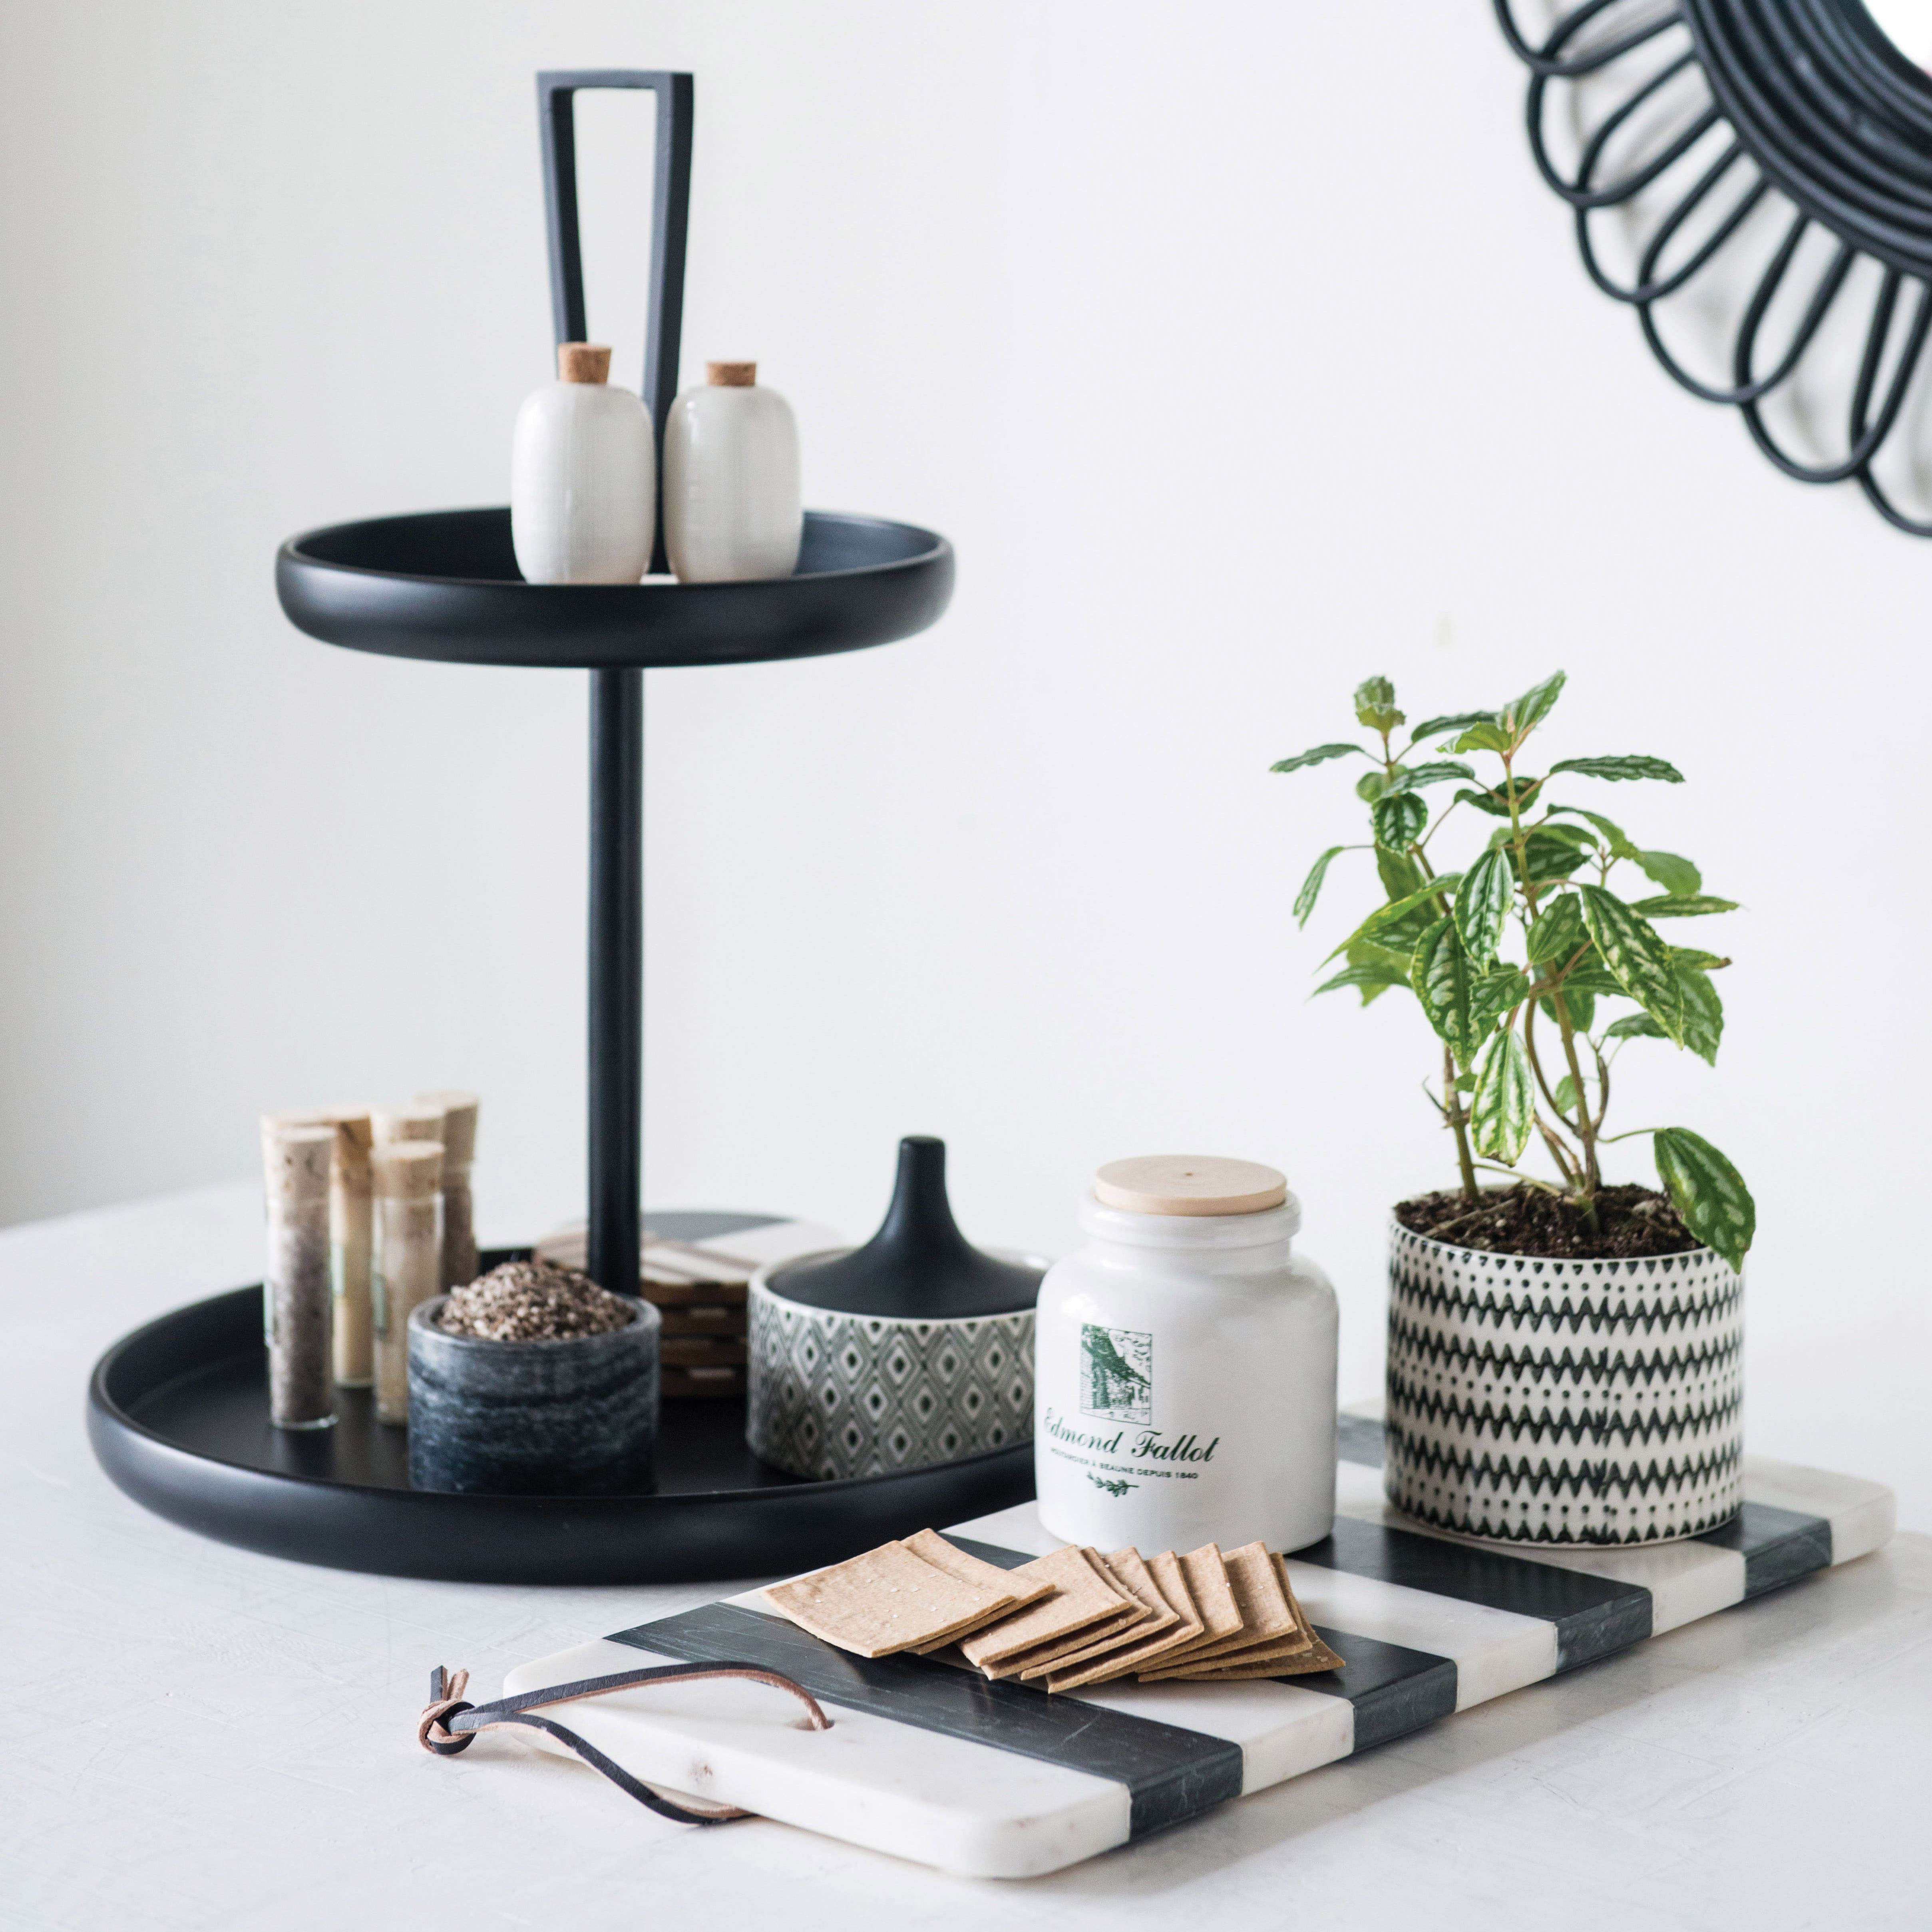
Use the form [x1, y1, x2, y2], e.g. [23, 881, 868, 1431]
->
[504, 1640, 1130, 1878]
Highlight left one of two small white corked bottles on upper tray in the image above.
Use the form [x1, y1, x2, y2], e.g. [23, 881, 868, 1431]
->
[510, 342, 657, 583]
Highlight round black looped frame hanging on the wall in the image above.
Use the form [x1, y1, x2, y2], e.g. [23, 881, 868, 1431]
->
[1493, 0, 1932, 537]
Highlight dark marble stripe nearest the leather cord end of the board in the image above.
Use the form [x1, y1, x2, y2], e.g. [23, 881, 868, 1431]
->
[611, 1600, 1242, 1837]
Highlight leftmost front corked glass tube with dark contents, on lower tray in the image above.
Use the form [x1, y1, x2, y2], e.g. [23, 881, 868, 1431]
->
[261, 1115, 336, 1430]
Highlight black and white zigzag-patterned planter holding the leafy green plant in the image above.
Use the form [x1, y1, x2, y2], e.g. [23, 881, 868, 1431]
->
[1385, 1221, 1745, 1544]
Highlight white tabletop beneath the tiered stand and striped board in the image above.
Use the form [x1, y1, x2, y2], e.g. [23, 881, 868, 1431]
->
[0, 1186, 1932, 1932]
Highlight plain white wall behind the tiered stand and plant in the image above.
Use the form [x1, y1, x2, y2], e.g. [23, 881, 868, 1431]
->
[0, 0, 1932, 1526]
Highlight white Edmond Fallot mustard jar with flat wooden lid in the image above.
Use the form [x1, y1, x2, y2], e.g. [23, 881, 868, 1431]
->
[1034, 1155, 1337, 1550]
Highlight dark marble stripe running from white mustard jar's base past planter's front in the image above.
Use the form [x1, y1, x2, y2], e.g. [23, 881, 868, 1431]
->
[1293, 1516, 1650, 1671]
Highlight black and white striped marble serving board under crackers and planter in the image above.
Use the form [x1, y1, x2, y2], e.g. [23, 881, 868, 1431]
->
[504, 1414, 1893, 1878]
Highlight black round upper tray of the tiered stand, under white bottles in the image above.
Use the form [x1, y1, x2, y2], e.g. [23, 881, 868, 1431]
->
[275, 510, 953, 671]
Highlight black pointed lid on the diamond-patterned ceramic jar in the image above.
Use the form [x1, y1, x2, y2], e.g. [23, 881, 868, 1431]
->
[769, 1134, 1045, 1321]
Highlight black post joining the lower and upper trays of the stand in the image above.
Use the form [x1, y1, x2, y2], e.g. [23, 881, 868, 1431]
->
[585, 671, 643, 1294]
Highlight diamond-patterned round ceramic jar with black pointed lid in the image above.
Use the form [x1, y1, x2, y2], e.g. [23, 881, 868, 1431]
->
[744, 1134, 1047, 1482]
